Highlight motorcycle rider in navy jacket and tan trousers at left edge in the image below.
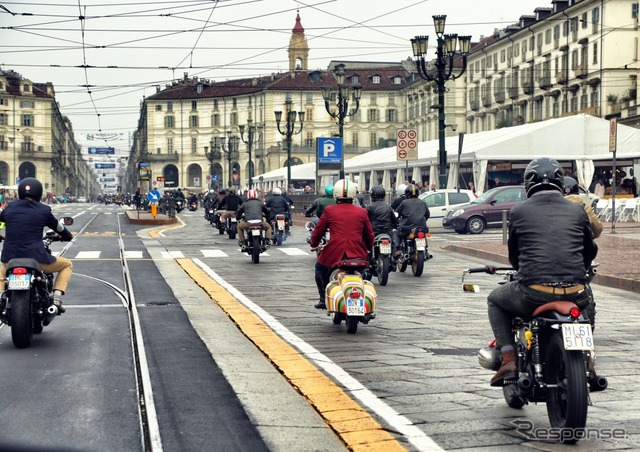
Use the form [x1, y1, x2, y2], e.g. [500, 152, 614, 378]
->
[0, 177, 73, 314]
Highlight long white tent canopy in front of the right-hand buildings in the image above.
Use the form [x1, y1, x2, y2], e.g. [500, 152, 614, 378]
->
[345, 114, 640, 190]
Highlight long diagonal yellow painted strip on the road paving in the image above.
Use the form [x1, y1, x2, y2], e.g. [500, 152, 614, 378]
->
[176, 259, 406, 452]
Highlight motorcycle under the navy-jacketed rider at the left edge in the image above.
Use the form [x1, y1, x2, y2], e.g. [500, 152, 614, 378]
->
[0, 217, 73, 348]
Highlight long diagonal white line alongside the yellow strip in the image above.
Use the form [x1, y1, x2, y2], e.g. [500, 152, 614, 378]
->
[193, 259, 444, 451]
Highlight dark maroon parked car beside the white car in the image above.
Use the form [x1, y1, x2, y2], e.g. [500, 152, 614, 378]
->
[442, 185, 527, 234]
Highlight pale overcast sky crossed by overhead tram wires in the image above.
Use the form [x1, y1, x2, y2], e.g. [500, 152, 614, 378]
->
[0, 0, 551, 153]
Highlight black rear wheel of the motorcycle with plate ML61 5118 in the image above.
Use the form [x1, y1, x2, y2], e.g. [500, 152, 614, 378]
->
[543, 332, 589, 444]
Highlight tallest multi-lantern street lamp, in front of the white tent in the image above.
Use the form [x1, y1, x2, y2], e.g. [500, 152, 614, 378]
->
[411, 15, 471, 189]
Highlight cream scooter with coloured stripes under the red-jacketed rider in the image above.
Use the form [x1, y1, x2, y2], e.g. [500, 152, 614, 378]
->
[318, 256, 377, 334]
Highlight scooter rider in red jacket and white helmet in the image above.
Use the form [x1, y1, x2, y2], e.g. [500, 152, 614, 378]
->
[310, 179, 373, 309]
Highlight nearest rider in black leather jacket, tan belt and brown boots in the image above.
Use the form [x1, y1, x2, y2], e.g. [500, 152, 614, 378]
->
[487, 157, 598, 386]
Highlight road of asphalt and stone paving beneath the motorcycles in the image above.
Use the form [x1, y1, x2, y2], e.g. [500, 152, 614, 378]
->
[0, 205, 640, 451]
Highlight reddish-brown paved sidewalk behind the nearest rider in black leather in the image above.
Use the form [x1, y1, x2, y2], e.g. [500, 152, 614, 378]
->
[444, 222, 640, 293]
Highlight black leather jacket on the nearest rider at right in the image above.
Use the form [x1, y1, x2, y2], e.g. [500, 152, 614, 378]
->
[508, 190, 598, 286]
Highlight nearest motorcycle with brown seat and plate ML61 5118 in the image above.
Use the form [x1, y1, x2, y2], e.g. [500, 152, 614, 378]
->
[462, 266, 608, 444]
